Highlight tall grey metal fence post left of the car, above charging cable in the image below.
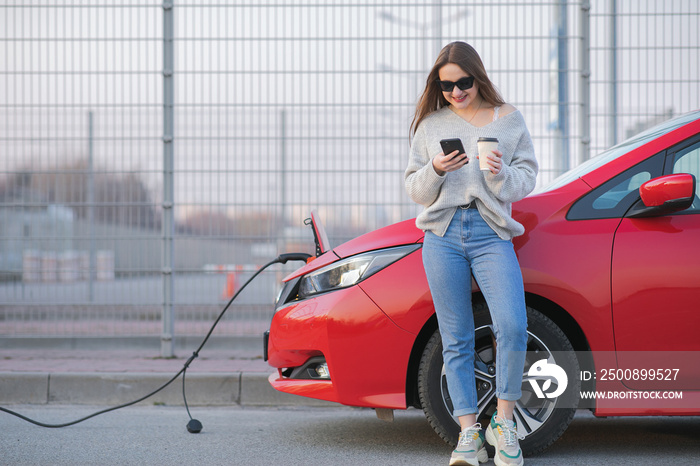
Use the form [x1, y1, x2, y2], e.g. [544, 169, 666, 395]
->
[160, 0, 175, 358]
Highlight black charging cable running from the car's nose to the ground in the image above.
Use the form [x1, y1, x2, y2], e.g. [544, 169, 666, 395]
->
[0, 253, 311, 434]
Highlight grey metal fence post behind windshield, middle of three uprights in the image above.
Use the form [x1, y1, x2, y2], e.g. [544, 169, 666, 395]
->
[578, 0, 591, 164]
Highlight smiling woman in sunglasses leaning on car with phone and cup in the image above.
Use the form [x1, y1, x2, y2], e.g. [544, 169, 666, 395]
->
[405, 42, 538, 465]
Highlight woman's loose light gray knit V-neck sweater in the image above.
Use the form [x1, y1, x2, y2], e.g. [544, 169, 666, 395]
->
[404, 107, 538, 240]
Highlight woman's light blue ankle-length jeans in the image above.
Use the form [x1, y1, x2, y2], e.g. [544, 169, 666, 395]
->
[423, 208, 527, 416]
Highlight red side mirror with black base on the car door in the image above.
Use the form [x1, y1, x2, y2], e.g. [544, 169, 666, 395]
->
[627, 173, 696, 218]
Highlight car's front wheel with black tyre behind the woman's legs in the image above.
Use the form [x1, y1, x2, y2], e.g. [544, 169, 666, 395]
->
[418, 303, 580, 455]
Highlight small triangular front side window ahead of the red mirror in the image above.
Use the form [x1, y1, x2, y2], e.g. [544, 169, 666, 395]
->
[566, 154, 662, 220]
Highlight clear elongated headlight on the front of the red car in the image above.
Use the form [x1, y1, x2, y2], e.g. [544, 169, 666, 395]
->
[299, 244, 421, 299]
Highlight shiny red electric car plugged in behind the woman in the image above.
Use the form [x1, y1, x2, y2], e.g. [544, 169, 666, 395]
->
[265, 111, 700, 454]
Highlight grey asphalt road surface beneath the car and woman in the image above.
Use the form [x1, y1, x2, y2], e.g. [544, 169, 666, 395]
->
[0, 405, 700, 465]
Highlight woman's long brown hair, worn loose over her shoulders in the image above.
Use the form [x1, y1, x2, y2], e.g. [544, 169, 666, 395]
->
[409, 42, 505, 139]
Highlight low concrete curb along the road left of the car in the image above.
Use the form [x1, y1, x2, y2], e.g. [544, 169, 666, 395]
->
[0, 372, 338, 407]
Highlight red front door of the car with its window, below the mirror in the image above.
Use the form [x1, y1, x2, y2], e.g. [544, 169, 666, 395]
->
[611, 138, 700, 390]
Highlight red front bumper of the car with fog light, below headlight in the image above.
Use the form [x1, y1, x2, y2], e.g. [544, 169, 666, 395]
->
[266, 285, 415, 409]
